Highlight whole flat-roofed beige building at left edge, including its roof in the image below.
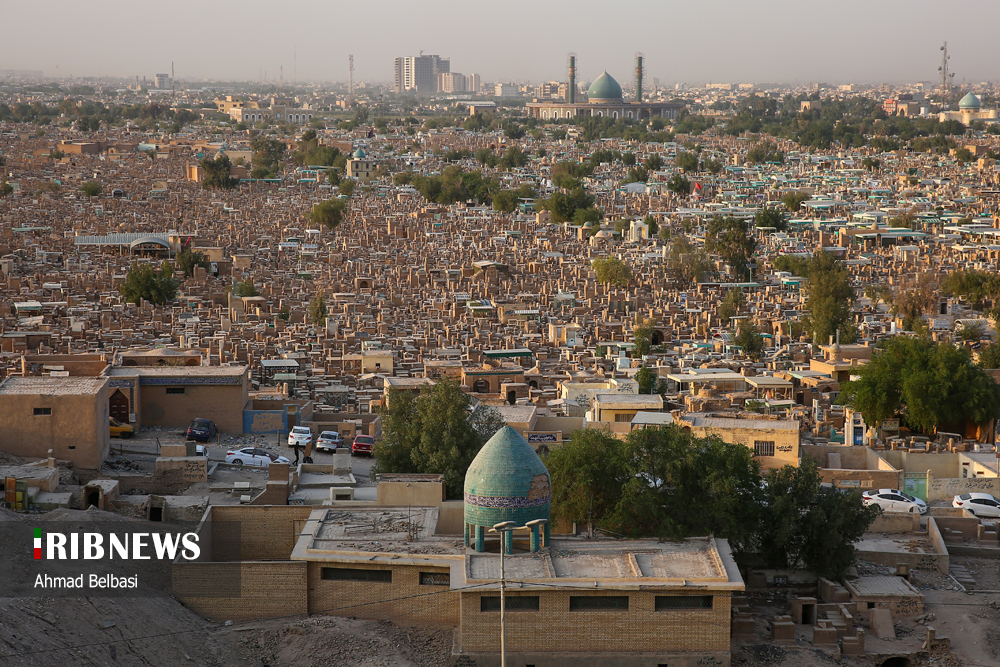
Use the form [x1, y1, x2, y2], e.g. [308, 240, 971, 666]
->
[0, 377, 111, 470]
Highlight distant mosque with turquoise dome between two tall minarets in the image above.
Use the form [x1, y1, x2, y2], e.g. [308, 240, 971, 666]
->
[526, 55, 684, 120]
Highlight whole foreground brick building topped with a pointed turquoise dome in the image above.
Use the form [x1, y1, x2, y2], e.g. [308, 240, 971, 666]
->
[173, 426, 745, 667]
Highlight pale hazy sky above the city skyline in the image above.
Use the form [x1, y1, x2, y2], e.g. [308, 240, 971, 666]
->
[0, 0, 1000, 85]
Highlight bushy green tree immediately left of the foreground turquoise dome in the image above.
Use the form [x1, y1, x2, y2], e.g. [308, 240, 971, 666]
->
[374, 381, 503, 498]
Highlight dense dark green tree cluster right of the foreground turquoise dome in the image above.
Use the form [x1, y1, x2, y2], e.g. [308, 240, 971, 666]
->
[545, 426, 880, 578]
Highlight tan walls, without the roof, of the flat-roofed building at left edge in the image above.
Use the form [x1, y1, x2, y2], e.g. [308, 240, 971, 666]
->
[0, 381, 111, 470]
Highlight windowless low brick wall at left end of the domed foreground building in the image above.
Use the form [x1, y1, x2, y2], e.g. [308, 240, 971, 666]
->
[172, 561, 308, 621]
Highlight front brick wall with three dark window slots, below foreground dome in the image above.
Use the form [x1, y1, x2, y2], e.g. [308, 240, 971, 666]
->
[461, 590, 730, 653]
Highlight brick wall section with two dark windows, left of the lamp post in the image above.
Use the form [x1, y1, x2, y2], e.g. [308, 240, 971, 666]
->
[309, 562, 458, 628]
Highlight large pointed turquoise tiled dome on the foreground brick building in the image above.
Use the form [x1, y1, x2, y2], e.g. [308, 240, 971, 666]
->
[465, 426, 552, 527]
